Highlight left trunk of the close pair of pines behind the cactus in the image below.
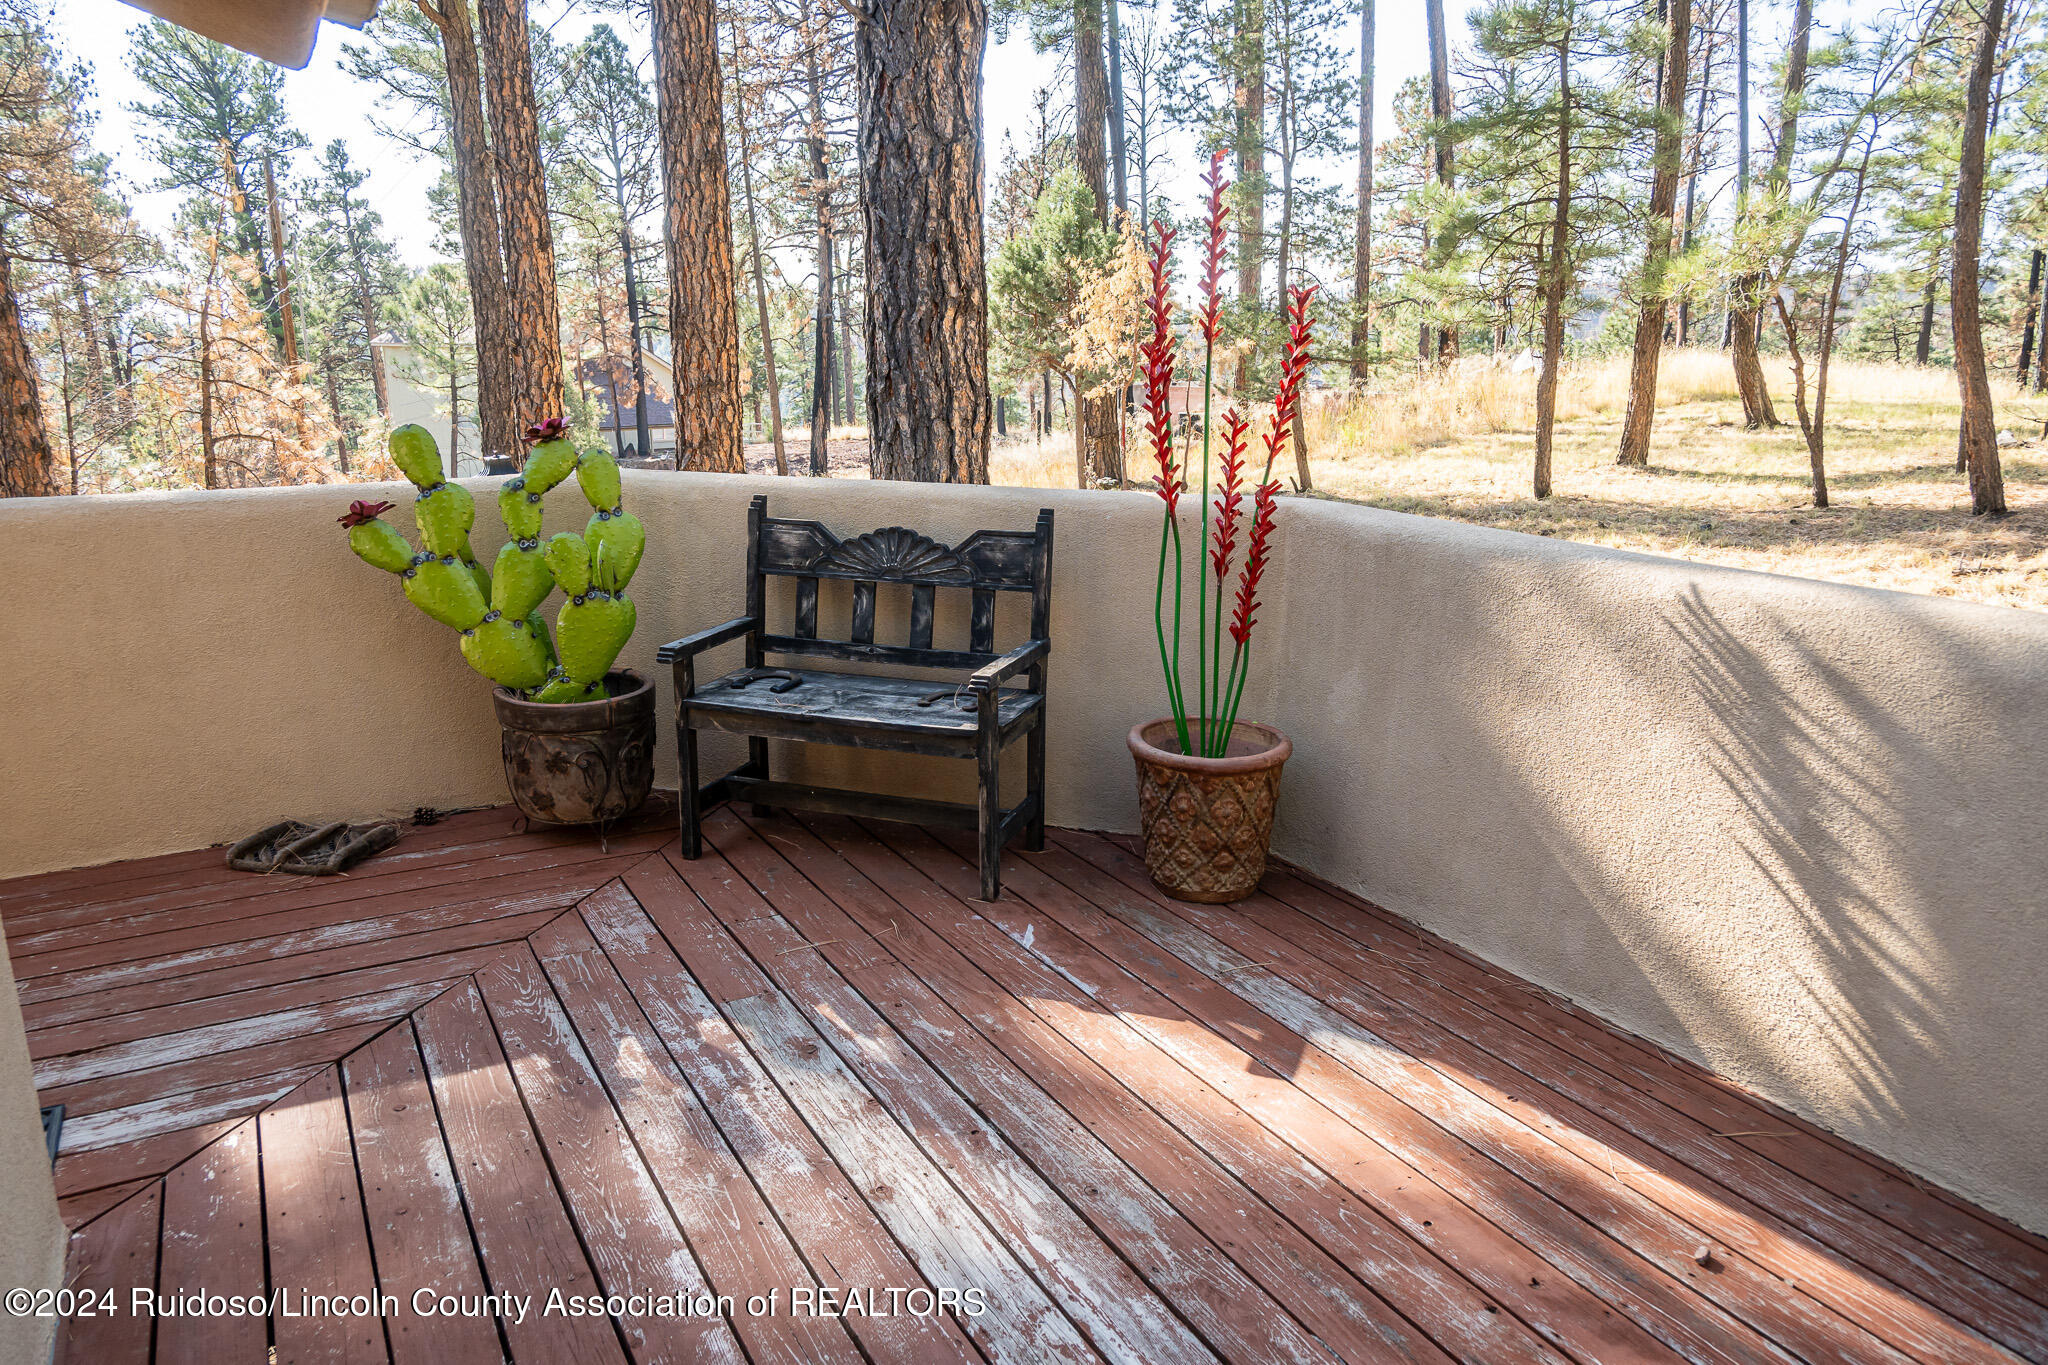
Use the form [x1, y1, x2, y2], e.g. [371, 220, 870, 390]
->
[417, 0, 524, 460]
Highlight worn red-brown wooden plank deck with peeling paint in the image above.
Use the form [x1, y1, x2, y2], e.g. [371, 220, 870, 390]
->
[0, 810, 2048, 1365]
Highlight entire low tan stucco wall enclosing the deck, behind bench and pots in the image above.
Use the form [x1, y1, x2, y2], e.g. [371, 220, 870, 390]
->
[0, 473, 2048, 1228]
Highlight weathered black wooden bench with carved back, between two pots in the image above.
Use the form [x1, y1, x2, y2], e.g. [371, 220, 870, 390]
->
[659, 495, 1053, 900]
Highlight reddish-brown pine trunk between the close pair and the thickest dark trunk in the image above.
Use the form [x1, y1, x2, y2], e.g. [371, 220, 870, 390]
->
[653, 0, 745, 473]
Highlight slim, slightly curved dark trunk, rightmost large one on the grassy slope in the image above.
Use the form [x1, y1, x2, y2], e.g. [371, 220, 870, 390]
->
[1948, 0, 2005, 516]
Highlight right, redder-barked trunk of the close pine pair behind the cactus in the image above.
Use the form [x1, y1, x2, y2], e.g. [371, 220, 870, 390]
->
[479, 0, 569, 444]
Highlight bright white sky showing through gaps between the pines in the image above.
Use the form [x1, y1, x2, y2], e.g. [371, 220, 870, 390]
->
[55, 0, 1462, 266]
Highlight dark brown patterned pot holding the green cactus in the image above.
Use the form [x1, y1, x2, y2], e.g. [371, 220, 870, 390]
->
[492, 669, 653, 825]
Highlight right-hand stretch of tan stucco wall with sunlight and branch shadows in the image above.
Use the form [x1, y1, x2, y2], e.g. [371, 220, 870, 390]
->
[1276, 508, 2048, 1224]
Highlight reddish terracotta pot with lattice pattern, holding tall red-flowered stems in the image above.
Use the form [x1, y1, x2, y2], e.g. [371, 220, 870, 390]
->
[1130, 718, 1294, 905]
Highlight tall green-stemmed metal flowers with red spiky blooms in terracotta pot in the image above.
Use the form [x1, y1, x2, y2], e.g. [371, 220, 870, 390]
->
[1139, 161, 1315, 757]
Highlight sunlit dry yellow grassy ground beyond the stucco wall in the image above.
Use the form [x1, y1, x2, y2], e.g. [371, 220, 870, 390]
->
[748, 352, 2048, 610]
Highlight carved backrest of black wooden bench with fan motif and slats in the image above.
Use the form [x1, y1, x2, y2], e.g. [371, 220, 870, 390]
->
[748, 493, 1053, 669]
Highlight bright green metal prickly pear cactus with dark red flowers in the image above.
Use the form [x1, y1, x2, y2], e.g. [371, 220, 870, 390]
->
[340, 417, 647, 702]
